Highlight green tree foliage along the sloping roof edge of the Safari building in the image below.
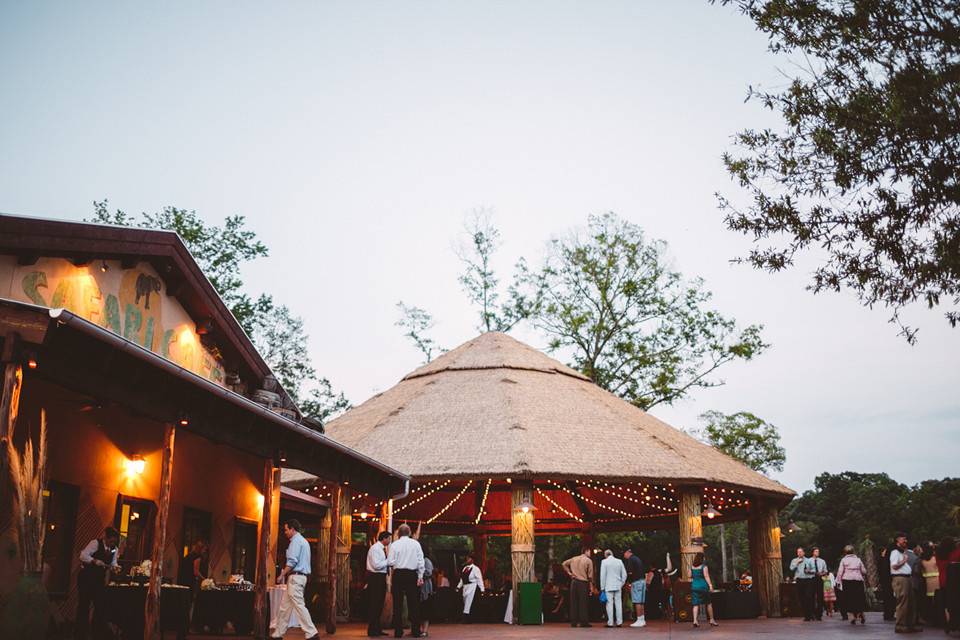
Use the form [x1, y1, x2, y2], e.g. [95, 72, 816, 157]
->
[89, 200, 350, 423]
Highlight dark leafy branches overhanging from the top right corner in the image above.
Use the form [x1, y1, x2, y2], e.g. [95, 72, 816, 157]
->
[718, 0, 960, 343]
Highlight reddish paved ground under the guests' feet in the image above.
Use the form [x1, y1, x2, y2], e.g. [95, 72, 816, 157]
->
[191, 613, 960, 640]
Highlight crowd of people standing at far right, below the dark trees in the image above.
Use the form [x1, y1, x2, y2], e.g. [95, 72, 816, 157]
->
[789, 533, 960, 633]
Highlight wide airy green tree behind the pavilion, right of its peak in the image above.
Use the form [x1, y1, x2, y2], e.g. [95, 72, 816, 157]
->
[531, 213, 767, 409]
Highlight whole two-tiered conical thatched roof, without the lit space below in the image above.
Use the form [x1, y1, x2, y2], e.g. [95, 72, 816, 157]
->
[318, 333, 793, 499]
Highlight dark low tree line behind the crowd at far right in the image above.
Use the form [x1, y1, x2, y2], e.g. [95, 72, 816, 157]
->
[783, 471, 960, 563]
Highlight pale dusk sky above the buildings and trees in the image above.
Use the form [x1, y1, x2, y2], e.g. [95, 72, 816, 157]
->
[0, 0, 960, 491]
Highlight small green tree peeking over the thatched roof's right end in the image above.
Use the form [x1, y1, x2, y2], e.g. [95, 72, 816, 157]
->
[696, 411, 787, 473]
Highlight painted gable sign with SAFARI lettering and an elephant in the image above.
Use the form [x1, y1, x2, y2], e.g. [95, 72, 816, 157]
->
[0, 256, 224, 385]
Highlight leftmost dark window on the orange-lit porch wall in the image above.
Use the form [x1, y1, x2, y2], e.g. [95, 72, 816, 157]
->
[43, 481, 80, 597]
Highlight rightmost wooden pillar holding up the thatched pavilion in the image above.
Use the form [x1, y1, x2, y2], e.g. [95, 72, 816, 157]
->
[747, 500, 783, 618]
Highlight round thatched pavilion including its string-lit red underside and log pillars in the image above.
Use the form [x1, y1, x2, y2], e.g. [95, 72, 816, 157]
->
[286, 333, 794, 616]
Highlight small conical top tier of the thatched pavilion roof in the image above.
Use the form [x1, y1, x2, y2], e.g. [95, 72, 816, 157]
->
[403, 331, 589, 380]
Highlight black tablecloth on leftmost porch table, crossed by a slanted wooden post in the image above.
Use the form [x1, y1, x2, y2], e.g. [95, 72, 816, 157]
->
[96, 585, 190, 639]
